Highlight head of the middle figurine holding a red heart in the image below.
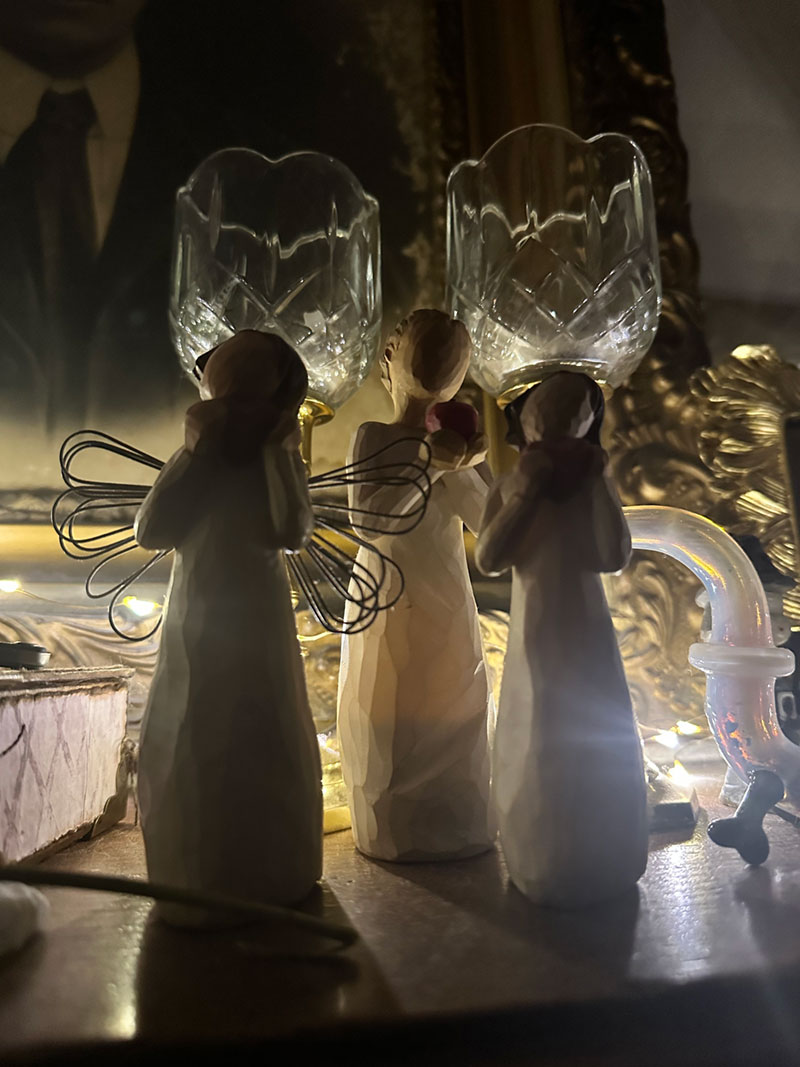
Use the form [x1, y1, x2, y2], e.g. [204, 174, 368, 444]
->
[382, 308, 471, 404]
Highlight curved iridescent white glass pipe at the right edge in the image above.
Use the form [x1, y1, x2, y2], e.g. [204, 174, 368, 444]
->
[624, 507, 800, 805]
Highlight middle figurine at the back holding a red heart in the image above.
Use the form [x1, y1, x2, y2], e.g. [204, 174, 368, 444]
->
[338, 309, 494, 861]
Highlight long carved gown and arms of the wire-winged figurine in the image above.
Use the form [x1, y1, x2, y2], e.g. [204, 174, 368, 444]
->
[137, 445, 322, 921]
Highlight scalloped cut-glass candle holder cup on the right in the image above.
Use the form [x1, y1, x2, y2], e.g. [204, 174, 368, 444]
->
[447, 126, 661, 400]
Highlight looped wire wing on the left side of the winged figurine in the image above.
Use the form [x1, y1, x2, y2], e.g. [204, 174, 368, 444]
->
[50, 430, 167, 641]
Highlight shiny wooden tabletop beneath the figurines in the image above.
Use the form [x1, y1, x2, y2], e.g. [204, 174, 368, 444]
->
[0, 755, 800, 1065]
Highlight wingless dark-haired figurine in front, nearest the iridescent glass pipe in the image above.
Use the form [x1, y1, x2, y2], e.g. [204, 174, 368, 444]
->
[476, 372, 647, 908]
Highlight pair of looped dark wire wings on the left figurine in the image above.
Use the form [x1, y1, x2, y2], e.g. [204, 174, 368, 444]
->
[51, 430, 431, 641]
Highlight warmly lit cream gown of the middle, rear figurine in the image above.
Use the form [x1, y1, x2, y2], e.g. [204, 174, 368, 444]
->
[338, 423, 494, 861]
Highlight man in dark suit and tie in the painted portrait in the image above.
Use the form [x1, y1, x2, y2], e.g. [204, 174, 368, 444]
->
[0, 0, 418, 490]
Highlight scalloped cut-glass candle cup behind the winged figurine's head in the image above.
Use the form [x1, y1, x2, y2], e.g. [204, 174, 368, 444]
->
[170, 148, 382, 413]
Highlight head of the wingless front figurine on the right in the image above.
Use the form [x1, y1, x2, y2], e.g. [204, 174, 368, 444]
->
[506, 370, 605, 447]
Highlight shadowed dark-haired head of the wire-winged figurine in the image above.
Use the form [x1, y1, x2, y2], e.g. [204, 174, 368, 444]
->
[187, 330, 308, 463]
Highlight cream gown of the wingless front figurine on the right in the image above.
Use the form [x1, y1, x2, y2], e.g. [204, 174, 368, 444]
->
[481, 475, 647, 907]
